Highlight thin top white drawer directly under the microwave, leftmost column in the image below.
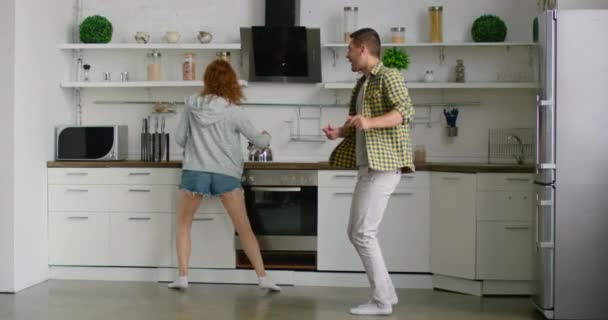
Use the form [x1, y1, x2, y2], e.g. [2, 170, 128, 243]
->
[47, 168, 114, 184]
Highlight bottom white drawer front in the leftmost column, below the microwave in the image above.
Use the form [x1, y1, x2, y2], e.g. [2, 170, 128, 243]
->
[49, 212, 110, 266]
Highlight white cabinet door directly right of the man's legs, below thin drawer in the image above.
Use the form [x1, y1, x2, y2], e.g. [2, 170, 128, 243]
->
[378, 189, 431, 272]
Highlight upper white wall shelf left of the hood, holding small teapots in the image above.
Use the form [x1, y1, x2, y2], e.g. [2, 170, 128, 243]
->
[58, 43, 241, 50]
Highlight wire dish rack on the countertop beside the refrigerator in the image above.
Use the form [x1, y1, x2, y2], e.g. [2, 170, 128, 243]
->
[488, 128, 536, 163]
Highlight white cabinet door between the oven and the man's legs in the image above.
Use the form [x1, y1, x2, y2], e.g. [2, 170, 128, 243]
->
[317, 185, 363, 271]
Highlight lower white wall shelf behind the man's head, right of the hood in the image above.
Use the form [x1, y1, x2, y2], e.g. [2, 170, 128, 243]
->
[323, 82, 538, 90]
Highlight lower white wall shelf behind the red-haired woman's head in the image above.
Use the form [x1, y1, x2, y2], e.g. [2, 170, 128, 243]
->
[61, 80, 249, 89]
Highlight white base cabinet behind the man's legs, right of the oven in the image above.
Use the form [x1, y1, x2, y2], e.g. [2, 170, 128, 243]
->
[317, 171, 430, 272]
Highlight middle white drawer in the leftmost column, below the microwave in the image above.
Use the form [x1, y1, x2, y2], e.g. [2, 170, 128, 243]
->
[48, 185, 111, 212]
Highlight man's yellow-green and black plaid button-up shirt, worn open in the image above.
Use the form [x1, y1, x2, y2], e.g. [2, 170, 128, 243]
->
[329, 63, 415, 172]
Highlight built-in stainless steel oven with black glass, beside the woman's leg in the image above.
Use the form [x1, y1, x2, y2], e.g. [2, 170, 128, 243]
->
[236, 170, 318, 251]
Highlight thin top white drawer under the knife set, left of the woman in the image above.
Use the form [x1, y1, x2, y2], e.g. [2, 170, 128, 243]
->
[112, 168, 181, 185]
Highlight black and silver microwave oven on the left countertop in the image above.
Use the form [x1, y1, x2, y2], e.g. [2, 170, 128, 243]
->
[55, 125, 129, 161]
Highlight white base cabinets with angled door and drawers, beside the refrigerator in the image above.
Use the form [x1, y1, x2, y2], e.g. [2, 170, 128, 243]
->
[431, 173, 533, 295]
